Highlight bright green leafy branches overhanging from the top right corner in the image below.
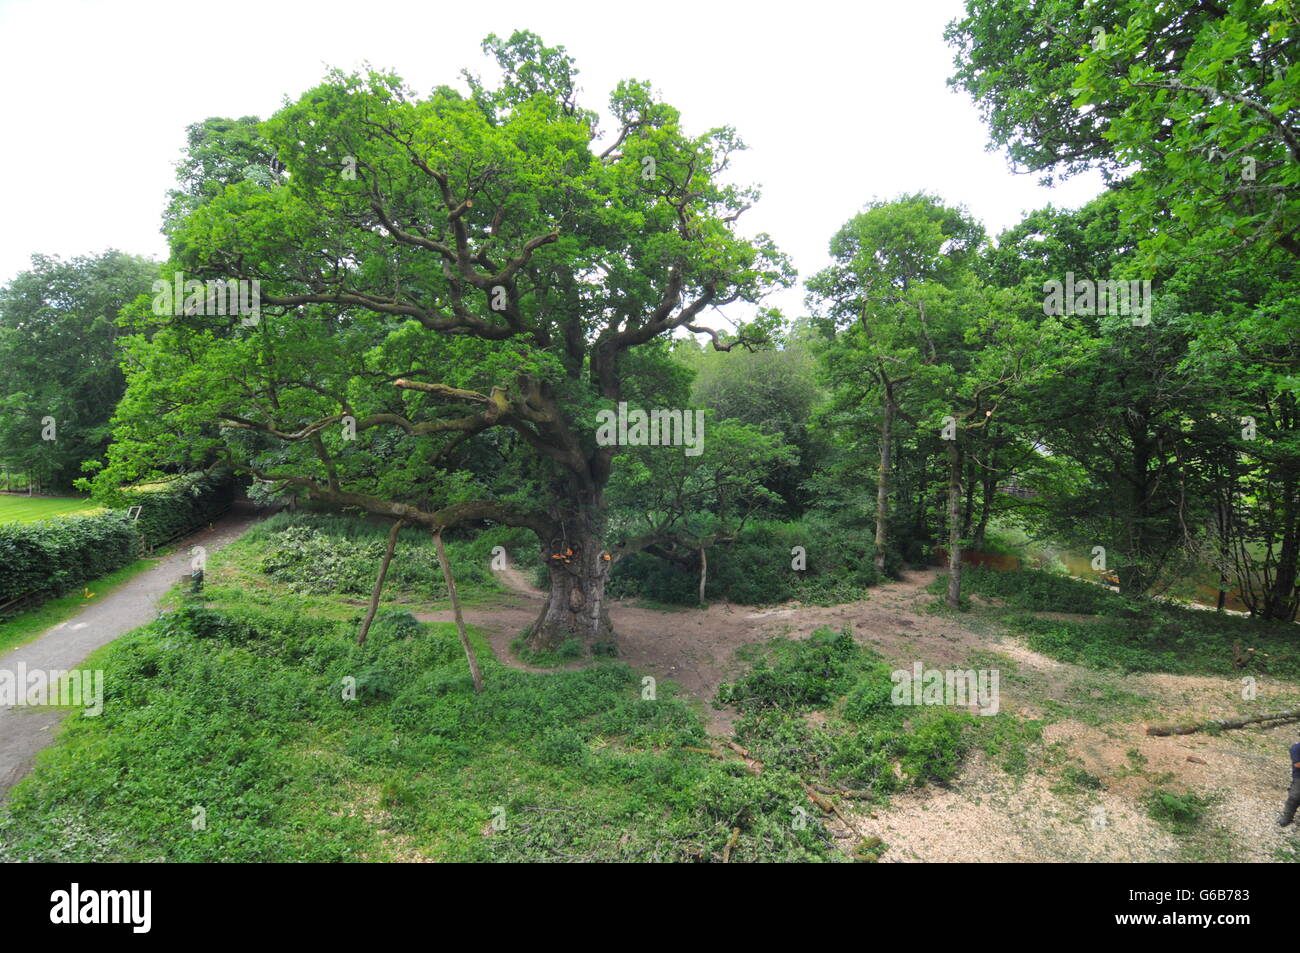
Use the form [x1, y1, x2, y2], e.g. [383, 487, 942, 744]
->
[948, 0, 1300, 263]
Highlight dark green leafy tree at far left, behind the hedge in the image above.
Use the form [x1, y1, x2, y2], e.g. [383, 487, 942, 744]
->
[0, 251, 157, 490]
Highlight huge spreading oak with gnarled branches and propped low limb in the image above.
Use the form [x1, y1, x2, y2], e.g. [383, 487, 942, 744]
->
[98, 33, 792, 650]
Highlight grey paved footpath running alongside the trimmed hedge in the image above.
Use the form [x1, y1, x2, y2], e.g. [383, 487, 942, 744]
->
[0, 502, 269, 801]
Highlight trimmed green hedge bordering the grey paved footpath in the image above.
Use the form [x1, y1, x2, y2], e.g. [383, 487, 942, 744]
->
[0, 475, 234, 606]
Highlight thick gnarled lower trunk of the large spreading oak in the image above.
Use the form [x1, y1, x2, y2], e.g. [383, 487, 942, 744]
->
[525, 508, 615, 653]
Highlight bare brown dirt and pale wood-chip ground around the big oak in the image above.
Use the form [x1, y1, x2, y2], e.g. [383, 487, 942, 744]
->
[417, 569, 1300, 862]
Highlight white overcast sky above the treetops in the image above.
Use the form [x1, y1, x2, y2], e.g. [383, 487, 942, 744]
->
[0, 0, 1101, 316]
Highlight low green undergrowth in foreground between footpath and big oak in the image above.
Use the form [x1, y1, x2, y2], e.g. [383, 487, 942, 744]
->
[0, 602, 835, 862]
